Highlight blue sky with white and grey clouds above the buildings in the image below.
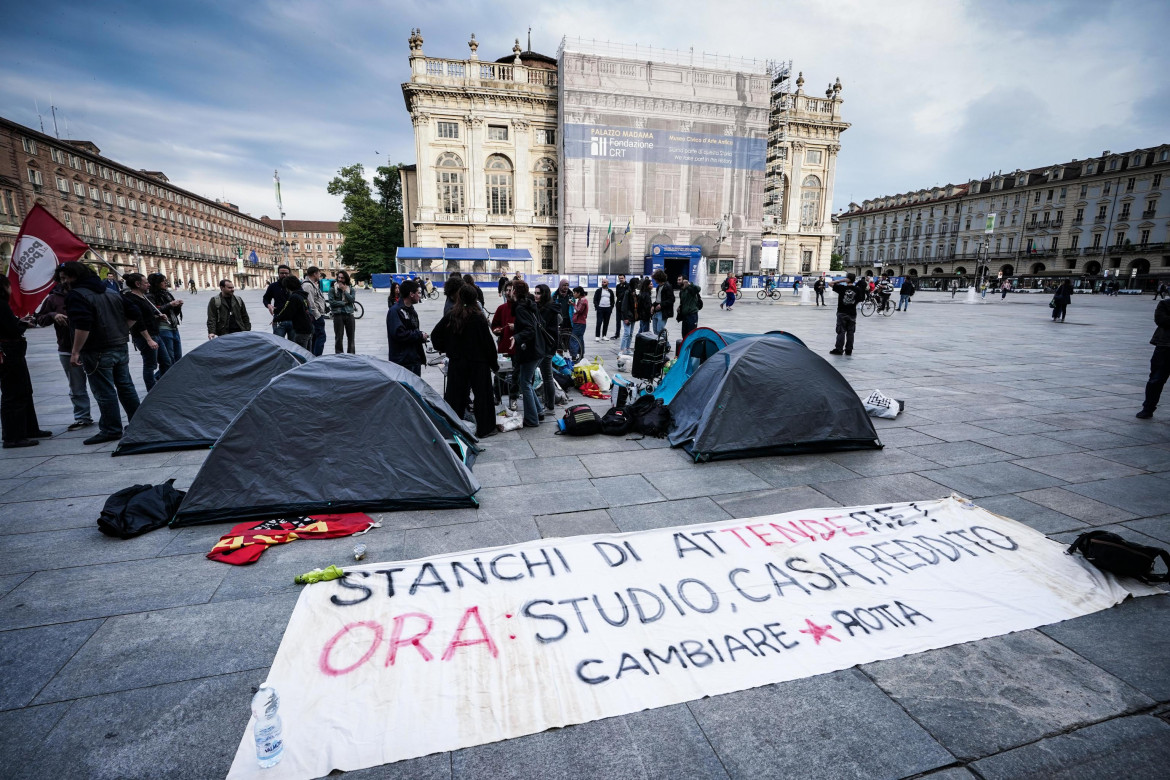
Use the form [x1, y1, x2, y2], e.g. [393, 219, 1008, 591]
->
[0, 0, 1170, 219]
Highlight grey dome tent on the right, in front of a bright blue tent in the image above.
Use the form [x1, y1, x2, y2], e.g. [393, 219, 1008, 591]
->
[667, 336, 882, 462]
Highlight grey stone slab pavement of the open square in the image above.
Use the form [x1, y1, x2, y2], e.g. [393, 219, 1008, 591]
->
[0, 291, 1170, 779]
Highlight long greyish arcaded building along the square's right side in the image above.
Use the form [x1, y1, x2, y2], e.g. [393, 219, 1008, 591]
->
[837, 144, 1170, 282]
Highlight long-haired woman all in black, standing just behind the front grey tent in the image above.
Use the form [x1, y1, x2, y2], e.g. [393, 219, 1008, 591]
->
[431, 284, 500, 439]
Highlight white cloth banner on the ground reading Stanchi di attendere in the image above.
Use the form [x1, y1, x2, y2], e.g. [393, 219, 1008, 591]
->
[228, 496, 1161, 779]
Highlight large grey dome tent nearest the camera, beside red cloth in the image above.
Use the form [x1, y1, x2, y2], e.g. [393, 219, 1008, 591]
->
[171, 354, 480, 527]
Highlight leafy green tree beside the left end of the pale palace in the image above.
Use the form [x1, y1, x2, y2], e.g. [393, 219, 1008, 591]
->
[326, 163, 402, 278]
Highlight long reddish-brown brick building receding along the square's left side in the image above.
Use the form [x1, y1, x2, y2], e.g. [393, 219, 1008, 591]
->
[0, 118, 280, 288]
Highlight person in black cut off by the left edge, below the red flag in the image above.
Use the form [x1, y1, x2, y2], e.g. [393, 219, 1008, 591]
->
[0, 276, 53, 449]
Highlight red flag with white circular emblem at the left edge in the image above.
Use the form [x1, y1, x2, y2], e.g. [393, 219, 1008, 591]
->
[8, 203, 89, 317]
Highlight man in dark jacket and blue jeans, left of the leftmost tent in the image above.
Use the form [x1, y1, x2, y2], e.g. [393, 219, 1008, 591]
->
[61, 262, 138, 444]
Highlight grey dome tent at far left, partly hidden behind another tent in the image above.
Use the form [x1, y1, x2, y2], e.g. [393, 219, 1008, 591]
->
[113, 331, 312, 455]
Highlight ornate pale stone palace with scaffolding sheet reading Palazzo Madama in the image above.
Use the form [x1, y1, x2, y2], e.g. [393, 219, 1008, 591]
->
[401, 30, 848, 274]
